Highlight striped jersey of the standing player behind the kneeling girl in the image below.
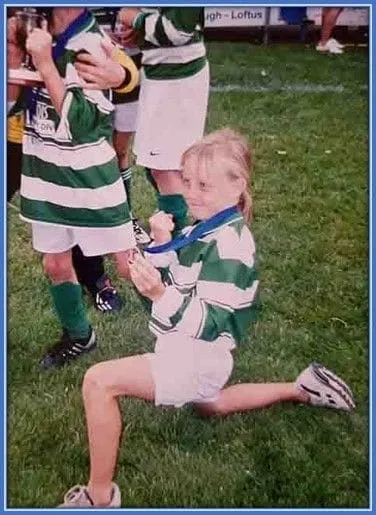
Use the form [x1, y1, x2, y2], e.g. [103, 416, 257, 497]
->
[133, 7, 207, 80]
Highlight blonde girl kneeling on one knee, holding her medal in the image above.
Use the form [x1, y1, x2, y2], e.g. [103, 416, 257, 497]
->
[57, 129, 355, 507]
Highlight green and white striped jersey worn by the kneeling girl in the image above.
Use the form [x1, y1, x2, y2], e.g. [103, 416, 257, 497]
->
[148, 213, 259, 348]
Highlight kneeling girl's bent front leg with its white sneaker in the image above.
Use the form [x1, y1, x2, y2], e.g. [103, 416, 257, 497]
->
[58, 355, 155, 507]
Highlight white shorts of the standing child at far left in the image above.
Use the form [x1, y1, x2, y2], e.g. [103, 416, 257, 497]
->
[31, 221, 136, 256]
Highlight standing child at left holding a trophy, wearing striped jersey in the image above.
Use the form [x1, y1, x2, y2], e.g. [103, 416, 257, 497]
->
[16, 7, 138, 369]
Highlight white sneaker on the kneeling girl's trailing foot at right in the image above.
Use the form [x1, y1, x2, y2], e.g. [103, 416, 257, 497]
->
[294, 363, 355, 411]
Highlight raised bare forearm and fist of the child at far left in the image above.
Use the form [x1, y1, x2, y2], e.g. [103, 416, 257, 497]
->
[26, 28, 66, 115]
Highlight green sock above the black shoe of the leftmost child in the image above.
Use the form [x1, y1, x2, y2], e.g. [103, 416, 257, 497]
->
[50, 282, 90, 339]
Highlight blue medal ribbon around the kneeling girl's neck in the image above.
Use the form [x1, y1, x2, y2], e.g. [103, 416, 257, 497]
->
[143, 206, 238, 254]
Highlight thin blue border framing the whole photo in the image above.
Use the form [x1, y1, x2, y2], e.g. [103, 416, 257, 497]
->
[0, 0, 376, 514]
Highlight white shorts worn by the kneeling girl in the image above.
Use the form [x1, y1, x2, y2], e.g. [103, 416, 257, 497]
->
[145, 332, 233, 408]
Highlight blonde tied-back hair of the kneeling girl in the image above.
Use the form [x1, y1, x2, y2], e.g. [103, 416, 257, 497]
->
[181, 128, 252, 221]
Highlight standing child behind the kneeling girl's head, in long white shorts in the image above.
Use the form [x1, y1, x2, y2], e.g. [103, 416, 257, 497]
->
[119, 7, 209, 236]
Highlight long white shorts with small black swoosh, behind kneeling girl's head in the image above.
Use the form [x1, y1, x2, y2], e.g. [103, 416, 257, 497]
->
[133, 65, 209, 170]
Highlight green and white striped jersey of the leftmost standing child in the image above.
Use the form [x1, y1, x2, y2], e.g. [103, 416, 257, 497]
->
[21, 11, 130, 227]
